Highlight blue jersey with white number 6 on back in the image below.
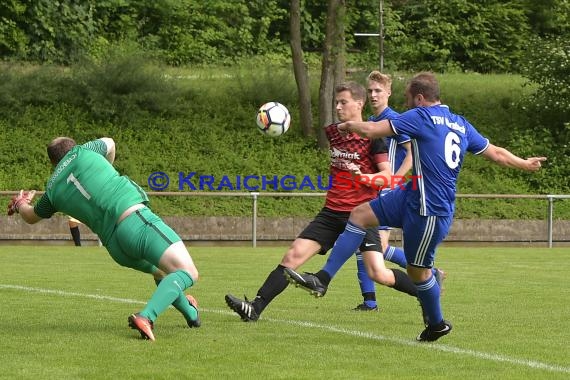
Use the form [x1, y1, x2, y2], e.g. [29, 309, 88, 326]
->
[390, 104, 489, 216]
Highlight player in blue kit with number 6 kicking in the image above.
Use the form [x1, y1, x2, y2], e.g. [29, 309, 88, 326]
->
[285, 73, 546, 342]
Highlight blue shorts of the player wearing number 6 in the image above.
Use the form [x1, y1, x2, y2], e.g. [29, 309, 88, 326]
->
[370, 188, 453, 268]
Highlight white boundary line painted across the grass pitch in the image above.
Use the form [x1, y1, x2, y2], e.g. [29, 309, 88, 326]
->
[4, 284, 570, 373]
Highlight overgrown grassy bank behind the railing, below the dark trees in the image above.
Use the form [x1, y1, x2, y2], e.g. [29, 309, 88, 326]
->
[0, 54, 570, 218]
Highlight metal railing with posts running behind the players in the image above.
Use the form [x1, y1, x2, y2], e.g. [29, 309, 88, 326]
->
[0, 191, 570, 248]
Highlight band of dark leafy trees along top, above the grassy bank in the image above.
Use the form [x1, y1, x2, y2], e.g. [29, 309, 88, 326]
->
[0, 0, 570, 73]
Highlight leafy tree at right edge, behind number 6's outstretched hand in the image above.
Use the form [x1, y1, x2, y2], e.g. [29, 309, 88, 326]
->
[511, 0, 570, 193]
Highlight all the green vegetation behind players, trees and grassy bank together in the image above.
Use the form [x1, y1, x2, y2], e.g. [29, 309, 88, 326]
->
[0, 0, 570, 223]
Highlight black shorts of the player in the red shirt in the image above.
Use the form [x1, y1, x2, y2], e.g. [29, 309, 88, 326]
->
[297, 207, 382, 255]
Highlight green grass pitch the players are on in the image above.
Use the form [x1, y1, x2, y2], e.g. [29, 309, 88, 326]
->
[0, 245, 570, 380]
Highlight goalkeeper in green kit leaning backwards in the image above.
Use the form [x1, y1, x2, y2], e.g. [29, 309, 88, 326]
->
[8, 137, 200, 340]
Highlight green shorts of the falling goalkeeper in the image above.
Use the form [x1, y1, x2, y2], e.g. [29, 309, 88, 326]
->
[106, 207, 182, 273]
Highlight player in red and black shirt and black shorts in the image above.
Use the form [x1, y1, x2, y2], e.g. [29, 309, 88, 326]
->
[225, 82, 417, 322]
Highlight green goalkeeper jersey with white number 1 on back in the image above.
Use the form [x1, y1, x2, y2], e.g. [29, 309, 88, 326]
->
[34, 140, 148, 244]
